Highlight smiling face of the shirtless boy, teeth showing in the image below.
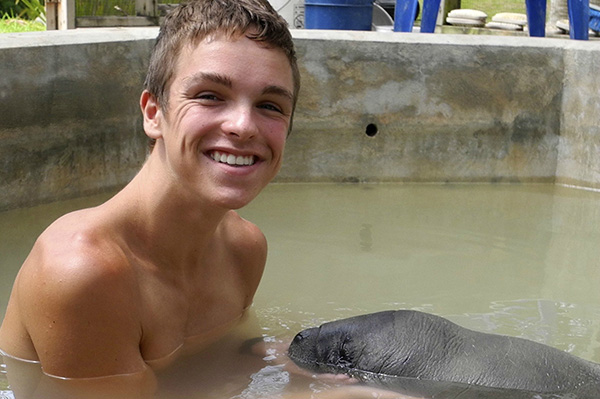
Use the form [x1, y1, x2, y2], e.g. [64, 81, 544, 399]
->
[150, 35, 293, 209]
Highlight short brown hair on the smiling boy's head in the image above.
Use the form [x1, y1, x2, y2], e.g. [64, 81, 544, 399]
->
[144, 0, 300, 147]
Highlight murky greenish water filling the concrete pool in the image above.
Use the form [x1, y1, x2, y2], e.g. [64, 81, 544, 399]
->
[0, 184, 600, 398]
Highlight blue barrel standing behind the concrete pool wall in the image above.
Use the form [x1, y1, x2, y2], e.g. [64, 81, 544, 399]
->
[304, 0, 373, 30]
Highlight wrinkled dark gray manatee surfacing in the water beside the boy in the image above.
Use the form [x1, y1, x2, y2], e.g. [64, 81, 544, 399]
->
[288, 310, 600, 399]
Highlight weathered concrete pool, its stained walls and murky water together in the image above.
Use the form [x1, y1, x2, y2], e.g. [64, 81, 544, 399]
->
[0, 28, 600, 398]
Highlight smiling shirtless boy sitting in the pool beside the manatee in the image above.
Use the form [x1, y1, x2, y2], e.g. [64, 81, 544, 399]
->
[0, 0, 299, 399]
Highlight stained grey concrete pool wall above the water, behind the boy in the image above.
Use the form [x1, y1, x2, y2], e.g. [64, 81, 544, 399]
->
[0, 28, 600, 210]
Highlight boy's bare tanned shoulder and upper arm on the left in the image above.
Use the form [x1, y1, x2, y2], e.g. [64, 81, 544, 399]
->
[3, 239, 156, 399]
